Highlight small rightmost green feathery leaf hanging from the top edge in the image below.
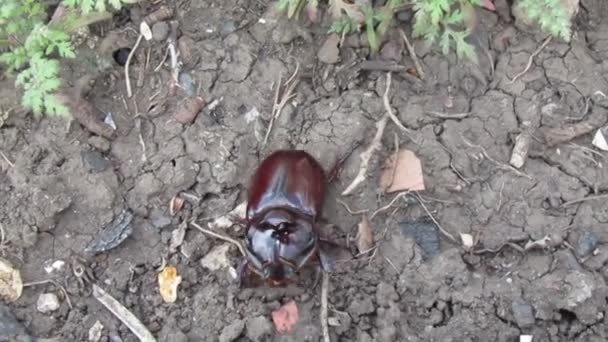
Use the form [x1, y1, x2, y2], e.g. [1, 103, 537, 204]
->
[518, 0, 572, 42]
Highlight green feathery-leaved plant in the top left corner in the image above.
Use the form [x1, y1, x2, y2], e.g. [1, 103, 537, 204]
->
[0, 0, 127, 118]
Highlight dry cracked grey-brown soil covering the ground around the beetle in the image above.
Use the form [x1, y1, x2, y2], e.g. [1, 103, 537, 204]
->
[0, 0, 608, 342]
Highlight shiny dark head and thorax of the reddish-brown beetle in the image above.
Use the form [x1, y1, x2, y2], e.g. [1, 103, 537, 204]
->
[246, 209, 318, 286]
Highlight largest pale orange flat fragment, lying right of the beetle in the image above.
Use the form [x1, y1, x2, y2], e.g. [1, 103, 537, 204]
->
[380, 150, 425, 193]
